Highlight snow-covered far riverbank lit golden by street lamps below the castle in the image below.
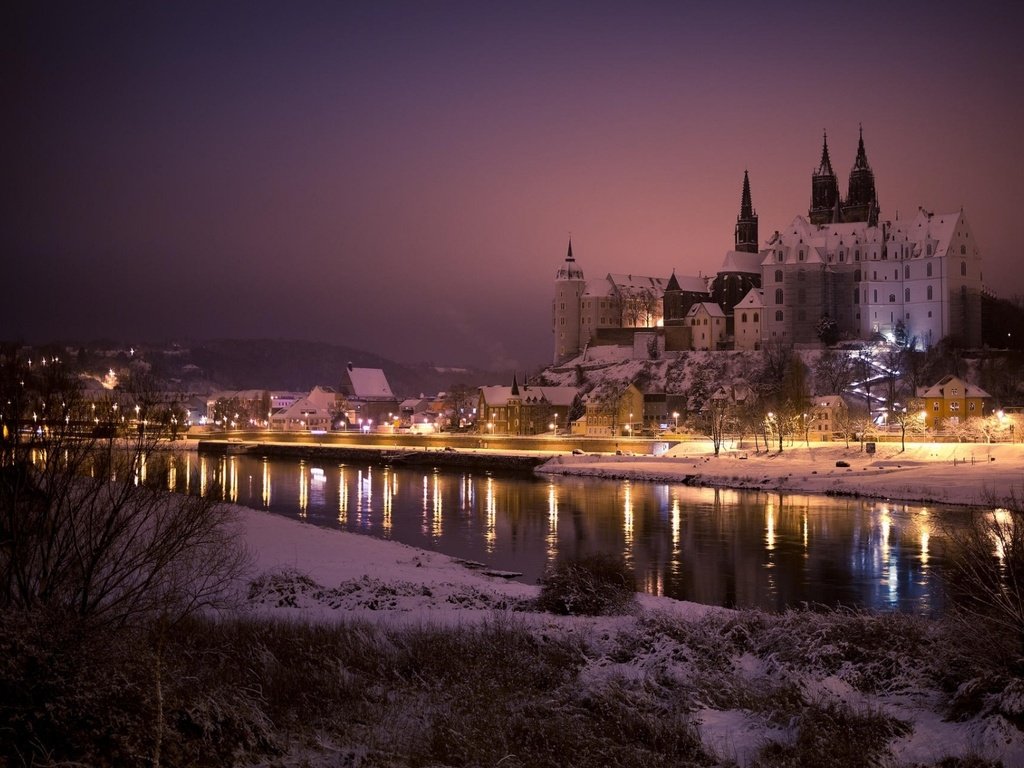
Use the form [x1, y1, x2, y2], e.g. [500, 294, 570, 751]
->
[539, 439, 1024, 505]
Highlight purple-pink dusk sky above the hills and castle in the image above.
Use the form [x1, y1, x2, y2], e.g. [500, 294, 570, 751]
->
[8, 0, 1024, 368]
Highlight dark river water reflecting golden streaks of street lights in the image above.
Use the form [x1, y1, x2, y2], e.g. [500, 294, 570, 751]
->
[166, 454, 963, 613]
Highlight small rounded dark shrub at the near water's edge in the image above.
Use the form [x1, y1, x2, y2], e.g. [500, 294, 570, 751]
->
[538, 553, 636, 616]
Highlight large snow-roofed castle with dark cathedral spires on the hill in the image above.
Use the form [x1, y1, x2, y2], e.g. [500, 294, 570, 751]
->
[552, 131, 982, 364]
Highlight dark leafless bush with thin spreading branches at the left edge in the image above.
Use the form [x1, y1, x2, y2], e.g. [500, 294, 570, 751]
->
[0, 352, 248, 626]
